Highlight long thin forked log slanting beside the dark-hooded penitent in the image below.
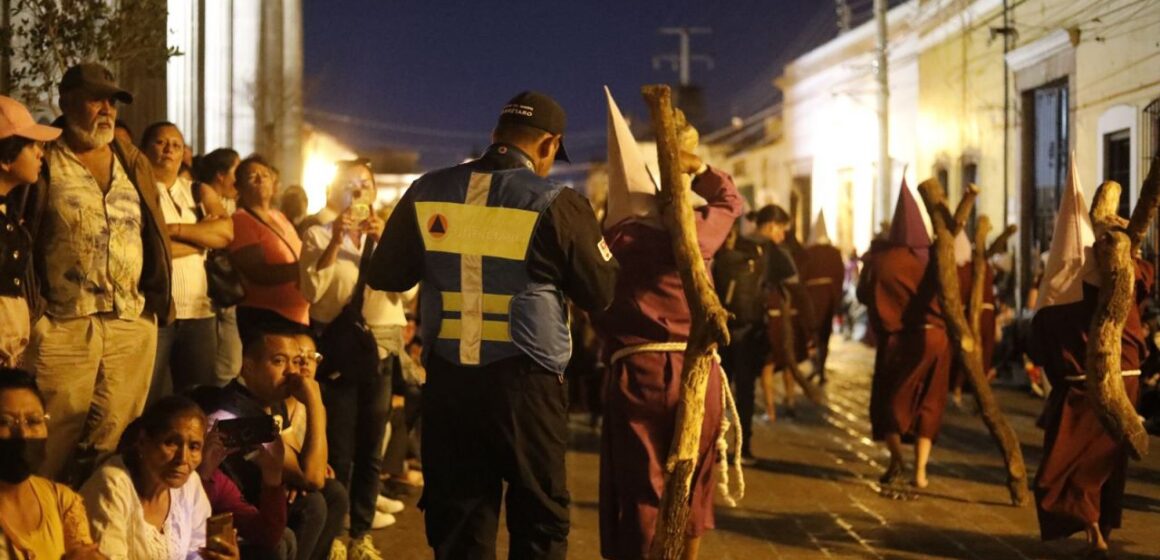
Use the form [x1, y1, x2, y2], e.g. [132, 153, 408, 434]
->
[919, 179, 1031, 506]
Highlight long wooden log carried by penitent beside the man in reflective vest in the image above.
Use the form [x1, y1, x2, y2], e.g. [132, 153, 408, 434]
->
[640, 86, 728, 560]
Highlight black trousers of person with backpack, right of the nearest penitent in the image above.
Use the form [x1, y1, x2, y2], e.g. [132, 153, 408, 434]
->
[722, 323, 769, 456]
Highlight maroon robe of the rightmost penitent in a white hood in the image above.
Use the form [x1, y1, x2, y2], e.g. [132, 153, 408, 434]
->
[1030, 264, 1152, 540]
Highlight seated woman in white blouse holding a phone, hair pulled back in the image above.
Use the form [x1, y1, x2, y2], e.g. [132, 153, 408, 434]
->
[80, 395, 239, 560]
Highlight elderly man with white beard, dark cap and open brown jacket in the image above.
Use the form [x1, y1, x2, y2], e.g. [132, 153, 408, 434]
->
[22, 63, 173, 483]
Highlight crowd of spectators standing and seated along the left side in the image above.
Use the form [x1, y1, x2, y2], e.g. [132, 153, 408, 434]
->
[0, 64, 423, 560]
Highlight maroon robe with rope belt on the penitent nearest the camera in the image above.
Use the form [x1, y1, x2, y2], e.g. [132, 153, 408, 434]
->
[594, 169, 741, 559]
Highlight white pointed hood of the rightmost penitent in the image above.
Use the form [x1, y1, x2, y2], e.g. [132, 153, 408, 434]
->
[1038, 158, 1099, 310]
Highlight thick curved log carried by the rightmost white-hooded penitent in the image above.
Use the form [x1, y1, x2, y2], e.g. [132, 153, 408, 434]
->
[1085, 183, 1155, 459]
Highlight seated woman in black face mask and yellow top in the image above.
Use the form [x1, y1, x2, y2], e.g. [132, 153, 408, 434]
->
[0, 368, 104, 560]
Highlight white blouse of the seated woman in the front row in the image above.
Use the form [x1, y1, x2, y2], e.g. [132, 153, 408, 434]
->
[80, 456, 212, 560]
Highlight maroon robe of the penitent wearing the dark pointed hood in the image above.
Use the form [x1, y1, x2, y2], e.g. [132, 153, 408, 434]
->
[858, 246, 951, 442]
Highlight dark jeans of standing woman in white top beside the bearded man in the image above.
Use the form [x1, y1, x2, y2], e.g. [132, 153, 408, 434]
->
[146, 317, 220, 406]
